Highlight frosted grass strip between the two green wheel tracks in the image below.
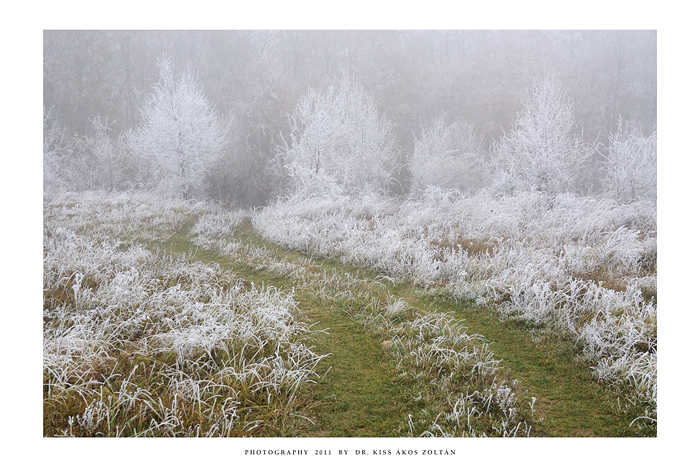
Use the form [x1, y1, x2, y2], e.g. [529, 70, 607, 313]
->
[191, 207, 531, 436]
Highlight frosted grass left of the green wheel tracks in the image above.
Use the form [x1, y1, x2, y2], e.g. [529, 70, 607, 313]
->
[43, 200, 323, 436]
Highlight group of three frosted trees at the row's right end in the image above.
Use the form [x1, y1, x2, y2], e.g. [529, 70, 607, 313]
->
[411, 77, 657, 202]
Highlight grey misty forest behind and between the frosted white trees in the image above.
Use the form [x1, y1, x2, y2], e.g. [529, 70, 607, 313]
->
[43, 30, 657, 206]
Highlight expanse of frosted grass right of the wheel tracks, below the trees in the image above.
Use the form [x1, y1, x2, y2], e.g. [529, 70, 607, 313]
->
[253, 188, 656, 426]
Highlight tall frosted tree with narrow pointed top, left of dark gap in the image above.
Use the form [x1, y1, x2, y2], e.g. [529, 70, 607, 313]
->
[130, 59, 225, 199]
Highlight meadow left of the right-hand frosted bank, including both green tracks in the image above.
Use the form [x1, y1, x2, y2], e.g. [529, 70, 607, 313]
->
[44, 192, 655, 437]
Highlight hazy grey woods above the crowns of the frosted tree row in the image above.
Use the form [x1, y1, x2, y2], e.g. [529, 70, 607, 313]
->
[44, 31, 656, 141]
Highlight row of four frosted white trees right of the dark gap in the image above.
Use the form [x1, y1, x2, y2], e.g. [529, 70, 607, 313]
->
[283, 73, 656, 202]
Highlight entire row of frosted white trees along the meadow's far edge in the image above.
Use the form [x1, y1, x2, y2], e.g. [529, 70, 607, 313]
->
[44, 59, 656, 201]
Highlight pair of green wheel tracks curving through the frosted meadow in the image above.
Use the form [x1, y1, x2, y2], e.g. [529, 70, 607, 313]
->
[168, 218, 635, 437]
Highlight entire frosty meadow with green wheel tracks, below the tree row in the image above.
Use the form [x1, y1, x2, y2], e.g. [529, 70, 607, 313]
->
[43, 190, 657, 437]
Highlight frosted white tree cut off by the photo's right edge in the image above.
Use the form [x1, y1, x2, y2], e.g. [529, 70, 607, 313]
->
[603, 125, 656, 203]
